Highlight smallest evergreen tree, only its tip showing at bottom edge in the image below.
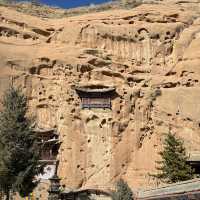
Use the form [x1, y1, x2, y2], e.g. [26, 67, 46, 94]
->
[113, 179, 133, 200]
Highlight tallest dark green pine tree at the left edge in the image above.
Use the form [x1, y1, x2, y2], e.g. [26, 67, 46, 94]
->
[0, 87, 42, 199]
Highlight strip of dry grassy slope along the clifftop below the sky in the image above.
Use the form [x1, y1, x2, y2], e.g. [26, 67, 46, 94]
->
[0, 0, 142, 18]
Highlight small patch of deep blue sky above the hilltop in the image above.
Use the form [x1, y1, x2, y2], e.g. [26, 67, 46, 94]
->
[40, 0, 109, 8]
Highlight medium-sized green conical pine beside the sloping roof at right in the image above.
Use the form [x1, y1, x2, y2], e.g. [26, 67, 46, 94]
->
[153, 133, 194, 183]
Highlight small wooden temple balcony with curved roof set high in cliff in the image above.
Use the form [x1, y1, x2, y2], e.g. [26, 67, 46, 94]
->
[76, 87, 115, 109]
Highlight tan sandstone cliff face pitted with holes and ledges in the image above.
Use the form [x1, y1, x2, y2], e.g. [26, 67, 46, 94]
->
[0, 0, 200, 191]
